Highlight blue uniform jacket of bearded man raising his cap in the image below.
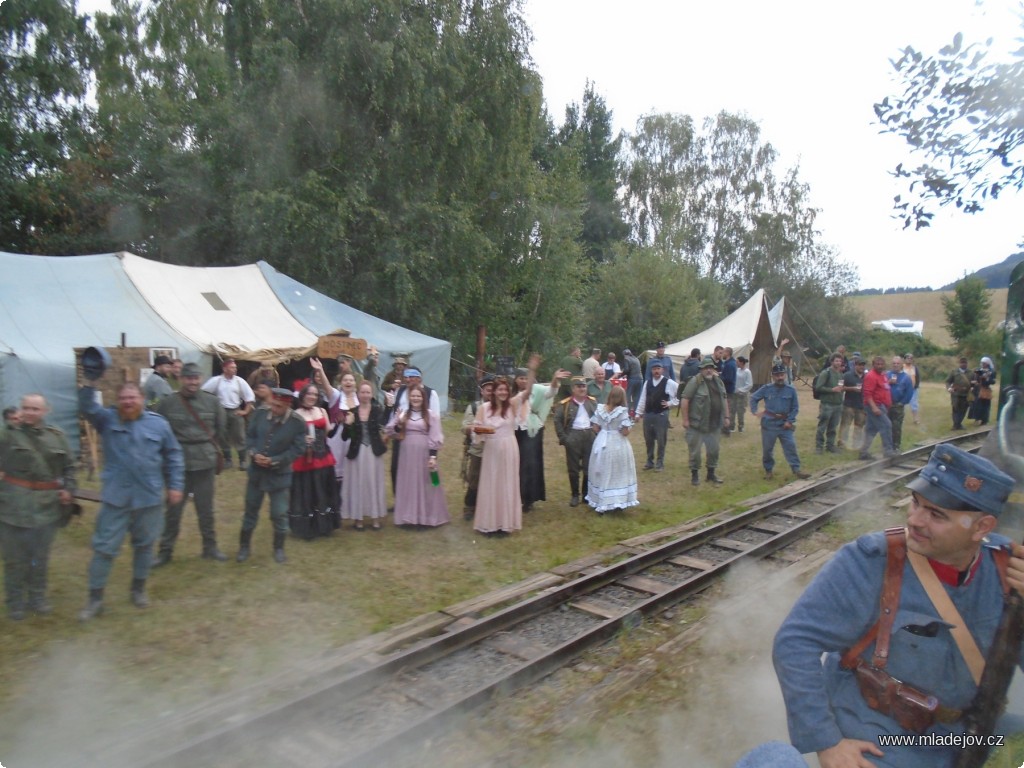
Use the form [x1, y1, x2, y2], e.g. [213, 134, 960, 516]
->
[78, 387, 185, 509]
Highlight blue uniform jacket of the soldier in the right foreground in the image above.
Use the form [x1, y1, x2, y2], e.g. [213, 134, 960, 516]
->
[773, 531, 1009, 768]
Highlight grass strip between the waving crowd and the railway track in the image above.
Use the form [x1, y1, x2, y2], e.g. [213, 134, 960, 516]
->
[0, 384, 1007, 766]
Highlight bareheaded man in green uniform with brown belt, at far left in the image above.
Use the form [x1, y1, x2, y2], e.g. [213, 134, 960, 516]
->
[0, 394, 75, 622]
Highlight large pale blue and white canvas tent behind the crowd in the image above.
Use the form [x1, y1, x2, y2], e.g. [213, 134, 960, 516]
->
[0, 252, 452, 450]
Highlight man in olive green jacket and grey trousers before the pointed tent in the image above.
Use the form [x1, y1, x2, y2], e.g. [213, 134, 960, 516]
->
[680, 357, 730, 485]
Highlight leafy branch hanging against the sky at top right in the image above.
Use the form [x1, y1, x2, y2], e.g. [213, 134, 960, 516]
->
[874, 12, 1024, 229]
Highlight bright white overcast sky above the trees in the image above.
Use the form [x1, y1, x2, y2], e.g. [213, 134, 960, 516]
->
[525, 0, 1024, 288]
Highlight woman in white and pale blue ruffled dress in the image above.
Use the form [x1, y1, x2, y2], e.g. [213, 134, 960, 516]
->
[587, 387, 640, 515]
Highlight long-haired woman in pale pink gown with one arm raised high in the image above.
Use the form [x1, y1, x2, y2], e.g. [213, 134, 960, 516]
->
[473, 354, 541, 537]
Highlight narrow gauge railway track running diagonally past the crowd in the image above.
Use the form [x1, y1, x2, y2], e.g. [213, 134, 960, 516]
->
[123, 431, 987, 768]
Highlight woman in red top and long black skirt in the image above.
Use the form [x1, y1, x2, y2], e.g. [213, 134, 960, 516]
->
[288, 384, 341, 539]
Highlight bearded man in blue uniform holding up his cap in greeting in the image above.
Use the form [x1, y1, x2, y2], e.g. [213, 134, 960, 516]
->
[78, 382, 184, 622]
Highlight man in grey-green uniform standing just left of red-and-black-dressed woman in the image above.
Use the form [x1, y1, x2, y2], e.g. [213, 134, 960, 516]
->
[234, 387, 306, 563]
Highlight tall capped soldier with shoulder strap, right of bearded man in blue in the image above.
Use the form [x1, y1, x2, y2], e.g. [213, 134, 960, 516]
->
[153, 362, 227, 568]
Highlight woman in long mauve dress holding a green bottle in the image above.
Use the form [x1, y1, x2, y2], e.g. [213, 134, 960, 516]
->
[387, 386, 448, 527]
